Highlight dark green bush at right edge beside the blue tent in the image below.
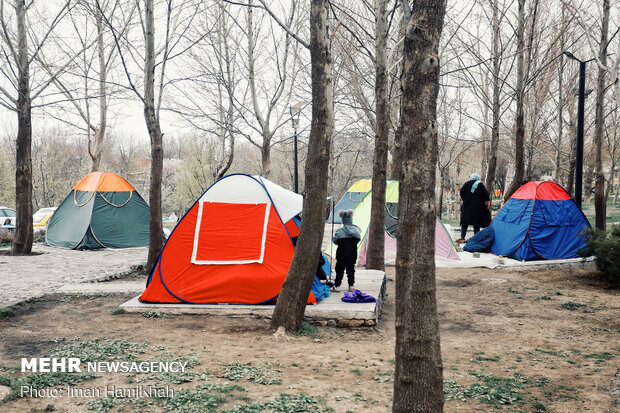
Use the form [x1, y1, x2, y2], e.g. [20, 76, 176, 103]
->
[580, 226, 620, 286]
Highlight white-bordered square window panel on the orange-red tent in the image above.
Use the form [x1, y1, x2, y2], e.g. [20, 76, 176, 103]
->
[191, 201, 271, 265]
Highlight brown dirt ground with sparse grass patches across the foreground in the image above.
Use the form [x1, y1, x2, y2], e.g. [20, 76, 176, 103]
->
[0, 268, 620, 413]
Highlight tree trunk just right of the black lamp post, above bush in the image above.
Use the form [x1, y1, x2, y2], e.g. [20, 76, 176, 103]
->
[594, 0, 618, 230]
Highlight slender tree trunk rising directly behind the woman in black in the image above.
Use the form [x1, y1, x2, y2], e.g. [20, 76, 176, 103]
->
[485, 0, 501, 194]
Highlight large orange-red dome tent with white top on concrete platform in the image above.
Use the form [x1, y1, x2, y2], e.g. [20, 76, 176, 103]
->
[140, 174, 316, 304]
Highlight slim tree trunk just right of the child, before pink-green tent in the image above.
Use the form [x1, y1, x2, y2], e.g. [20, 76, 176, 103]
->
[366, 0, 390, 270]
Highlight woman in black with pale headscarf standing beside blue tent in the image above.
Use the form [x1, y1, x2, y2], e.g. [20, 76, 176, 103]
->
[456, 173, 491, 243]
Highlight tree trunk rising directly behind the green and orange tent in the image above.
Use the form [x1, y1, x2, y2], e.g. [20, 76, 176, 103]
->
[88, 9, 108, 172]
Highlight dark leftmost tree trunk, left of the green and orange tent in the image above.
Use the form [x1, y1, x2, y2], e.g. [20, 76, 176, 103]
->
[12, 0, 33, 254]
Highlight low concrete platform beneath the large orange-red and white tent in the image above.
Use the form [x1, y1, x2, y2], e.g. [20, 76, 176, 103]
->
[120, 268, 386, 327]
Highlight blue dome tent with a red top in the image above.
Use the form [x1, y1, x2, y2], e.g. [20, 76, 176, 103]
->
[491, 181, 590, 260]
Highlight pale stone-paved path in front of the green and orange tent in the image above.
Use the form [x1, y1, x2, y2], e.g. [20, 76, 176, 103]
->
[0, 244, 148, 308]
